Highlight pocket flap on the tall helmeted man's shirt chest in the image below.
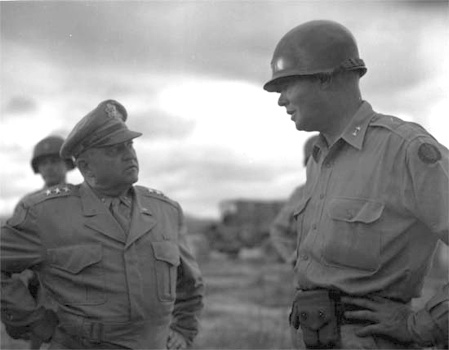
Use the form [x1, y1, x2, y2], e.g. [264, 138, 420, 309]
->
[328, 198, 384, 224]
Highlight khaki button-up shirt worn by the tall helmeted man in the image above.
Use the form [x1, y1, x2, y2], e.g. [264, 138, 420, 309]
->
[295, 102, 449, 346]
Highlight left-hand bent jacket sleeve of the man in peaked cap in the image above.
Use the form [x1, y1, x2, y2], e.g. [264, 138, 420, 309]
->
[0, 203, 43, 327]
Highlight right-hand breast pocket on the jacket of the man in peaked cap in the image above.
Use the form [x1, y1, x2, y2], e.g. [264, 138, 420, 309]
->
[151, 241, 180, 302]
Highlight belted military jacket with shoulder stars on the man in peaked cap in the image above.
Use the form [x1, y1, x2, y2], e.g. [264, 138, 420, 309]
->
[1, 183, 203, 348]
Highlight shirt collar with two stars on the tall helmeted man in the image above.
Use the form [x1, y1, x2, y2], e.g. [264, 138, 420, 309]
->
[312, 101, 375, 163]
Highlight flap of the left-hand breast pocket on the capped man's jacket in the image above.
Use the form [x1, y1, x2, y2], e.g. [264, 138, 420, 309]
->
[47, 244, 103, 274]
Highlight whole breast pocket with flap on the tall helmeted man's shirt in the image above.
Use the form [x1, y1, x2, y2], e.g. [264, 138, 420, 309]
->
[322, 198, 384, 272]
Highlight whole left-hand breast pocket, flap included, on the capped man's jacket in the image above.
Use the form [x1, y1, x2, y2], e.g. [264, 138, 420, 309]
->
[45, 244, 106, 305]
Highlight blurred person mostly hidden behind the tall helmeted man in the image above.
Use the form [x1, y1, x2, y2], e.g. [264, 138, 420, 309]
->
[270, 136, 318, 266]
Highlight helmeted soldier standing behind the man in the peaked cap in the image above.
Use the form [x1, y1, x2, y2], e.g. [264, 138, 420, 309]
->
[7, 135, 75, 349]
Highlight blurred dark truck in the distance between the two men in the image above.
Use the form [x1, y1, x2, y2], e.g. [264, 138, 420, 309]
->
[207, 199, 286, 257]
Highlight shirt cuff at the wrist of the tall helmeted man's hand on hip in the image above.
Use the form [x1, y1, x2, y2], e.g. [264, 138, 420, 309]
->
[407, 310, 435, 347]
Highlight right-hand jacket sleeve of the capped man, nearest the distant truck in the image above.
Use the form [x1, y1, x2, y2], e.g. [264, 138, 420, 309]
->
[171, 205, 204, 345]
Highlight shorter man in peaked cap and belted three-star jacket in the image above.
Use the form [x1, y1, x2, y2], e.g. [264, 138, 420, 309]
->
[1, 100, 204, 349]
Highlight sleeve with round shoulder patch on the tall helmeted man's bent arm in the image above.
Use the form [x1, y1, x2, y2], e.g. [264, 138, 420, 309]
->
[404, 136, 449, 348]
